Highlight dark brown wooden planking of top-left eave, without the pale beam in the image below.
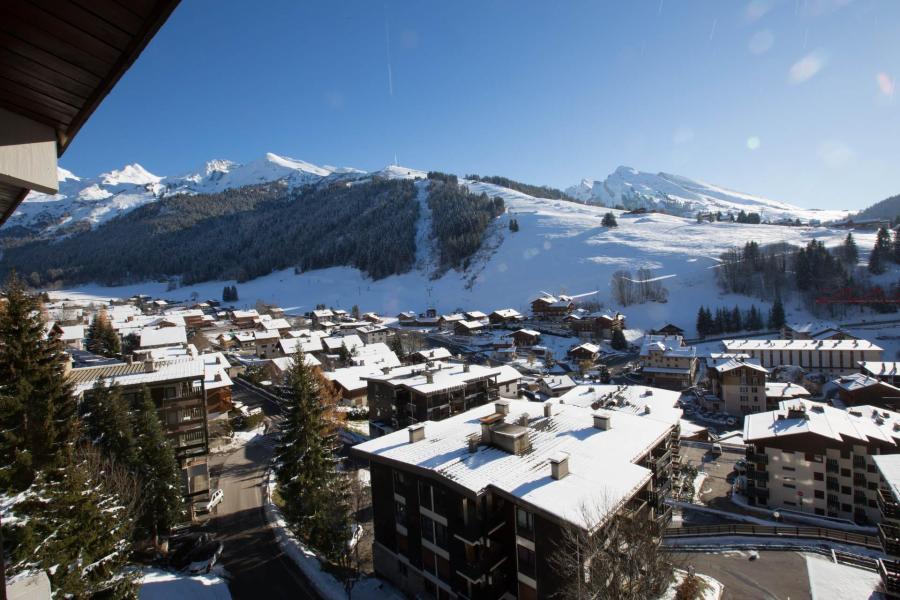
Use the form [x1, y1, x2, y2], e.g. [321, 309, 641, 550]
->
[0, 0, 179, 224]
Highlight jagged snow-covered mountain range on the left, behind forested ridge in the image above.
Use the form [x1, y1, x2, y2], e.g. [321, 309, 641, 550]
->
[4, 152, 370, 236]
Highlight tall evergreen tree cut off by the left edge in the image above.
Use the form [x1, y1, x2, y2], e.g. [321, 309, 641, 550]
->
[0, 273, 75, 490]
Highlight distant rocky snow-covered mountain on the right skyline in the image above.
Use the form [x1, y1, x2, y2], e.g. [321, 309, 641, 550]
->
[566, 167, 849, 221]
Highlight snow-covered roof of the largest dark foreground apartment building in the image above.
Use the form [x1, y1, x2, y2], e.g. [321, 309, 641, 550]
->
[354, 401, 671, 530]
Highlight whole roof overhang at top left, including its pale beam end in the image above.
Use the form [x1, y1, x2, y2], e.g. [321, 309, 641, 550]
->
[0, 0, 179, 225]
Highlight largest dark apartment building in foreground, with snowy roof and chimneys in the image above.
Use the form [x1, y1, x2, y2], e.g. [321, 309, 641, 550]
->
[352, 400, 680, 600]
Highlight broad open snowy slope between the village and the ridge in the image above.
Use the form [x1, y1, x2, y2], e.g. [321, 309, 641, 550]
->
[52, 182, 874, 333]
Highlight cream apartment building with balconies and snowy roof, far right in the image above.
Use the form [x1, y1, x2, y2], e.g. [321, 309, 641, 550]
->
[744, 400, 900, 523]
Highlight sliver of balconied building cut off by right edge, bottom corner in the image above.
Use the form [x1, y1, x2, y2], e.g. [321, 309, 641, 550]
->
[872, 454, 900, 598]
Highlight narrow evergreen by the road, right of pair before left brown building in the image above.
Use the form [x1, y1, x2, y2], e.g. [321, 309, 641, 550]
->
[133, 389, 184, 540]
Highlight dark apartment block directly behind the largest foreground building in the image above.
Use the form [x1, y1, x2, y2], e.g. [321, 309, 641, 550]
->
[360, 361, 500, 436]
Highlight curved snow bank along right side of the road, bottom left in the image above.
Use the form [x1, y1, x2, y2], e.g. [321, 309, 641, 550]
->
[265, 471, 404, 600]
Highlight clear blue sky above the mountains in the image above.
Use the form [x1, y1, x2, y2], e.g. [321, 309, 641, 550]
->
[62, 0, 900, 208]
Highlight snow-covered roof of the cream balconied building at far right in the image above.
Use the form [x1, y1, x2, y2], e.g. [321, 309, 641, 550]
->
[744, 399, 900, 445]
